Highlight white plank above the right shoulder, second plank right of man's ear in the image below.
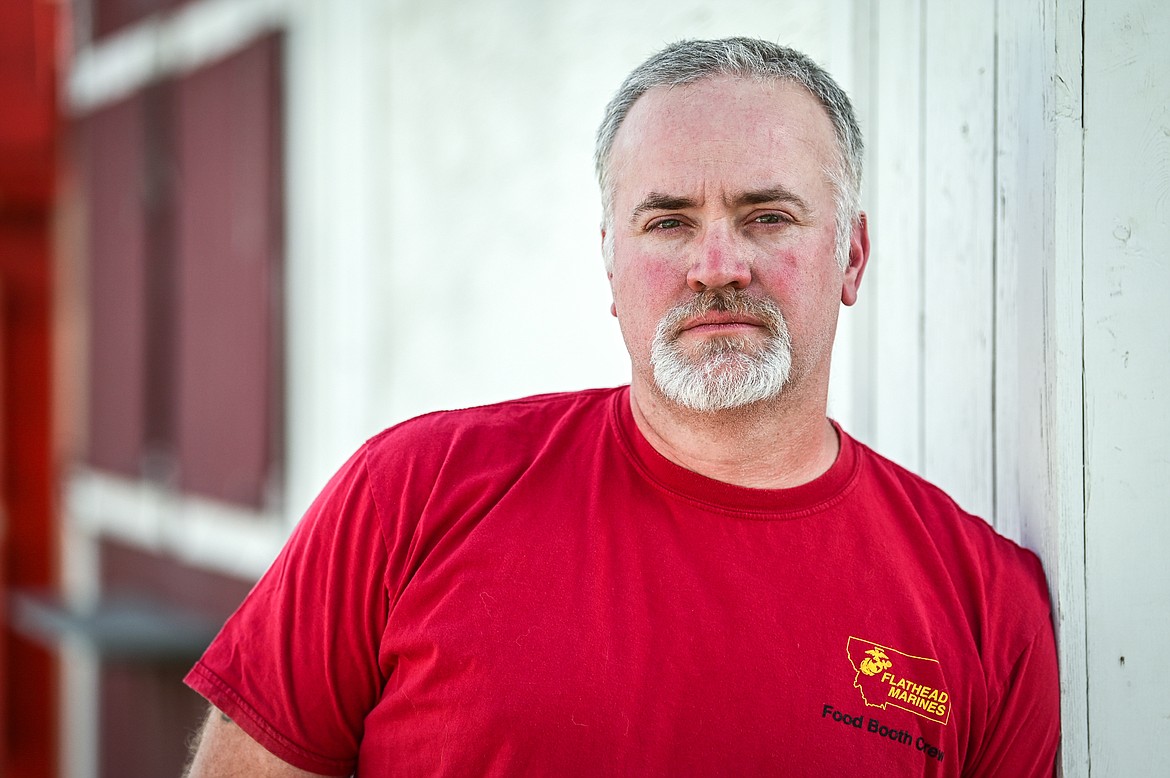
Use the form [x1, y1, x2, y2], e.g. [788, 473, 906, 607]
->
[923, 0, 996, 519]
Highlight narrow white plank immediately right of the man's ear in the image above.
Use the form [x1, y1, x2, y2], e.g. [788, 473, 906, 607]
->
[862, 0, 923, 473]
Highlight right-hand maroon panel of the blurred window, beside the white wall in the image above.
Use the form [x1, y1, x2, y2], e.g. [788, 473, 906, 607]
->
[174, 39, 281, 505]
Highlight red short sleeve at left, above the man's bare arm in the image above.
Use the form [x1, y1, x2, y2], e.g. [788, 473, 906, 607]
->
[185, 448, 388, 774]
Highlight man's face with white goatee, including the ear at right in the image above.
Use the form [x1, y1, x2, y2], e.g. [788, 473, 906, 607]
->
[607, 77, 868, 411]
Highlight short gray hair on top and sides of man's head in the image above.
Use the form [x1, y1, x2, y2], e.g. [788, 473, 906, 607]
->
[593, 37, 863, 269]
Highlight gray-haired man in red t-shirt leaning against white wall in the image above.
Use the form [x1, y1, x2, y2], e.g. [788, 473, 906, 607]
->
[187, 39, 1059, 776]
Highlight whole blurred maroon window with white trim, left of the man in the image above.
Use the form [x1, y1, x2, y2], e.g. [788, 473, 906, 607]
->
[80, 36, 283, 508]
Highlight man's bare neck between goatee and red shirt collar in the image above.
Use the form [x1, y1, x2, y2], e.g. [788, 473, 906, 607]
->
[629, 380, 840, 489]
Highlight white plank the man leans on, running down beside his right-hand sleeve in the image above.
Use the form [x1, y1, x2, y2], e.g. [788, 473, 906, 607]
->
[995, 0, 1088, 776]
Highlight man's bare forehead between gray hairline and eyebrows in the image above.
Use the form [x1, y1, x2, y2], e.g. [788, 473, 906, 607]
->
[610, 76, 839, 205]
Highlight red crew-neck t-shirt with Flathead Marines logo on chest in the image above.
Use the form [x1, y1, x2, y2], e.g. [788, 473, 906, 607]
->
[187, 388, 1059, 777]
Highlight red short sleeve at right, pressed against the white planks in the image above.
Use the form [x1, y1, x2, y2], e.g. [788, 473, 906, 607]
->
[963, 622, 1060, 778]
